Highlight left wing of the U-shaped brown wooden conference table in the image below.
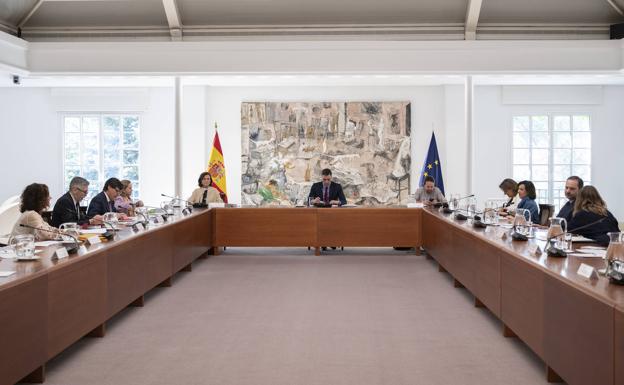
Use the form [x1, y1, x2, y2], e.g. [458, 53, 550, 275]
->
[0, 210, 212, 385]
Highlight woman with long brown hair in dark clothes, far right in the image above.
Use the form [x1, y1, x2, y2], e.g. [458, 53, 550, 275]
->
[568, 186, 620, 246]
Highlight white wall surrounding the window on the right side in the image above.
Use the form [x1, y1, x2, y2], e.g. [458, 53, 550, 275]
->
[473, 86, 624, 220]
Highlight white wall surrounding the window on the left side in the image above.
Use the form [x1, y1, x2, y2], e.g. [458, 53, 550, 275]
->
[0, 88, 174, 204]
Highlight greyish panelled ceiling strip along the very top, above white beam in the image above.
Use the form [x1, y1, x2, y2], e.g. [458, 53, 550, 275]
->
[0, 0, 624, 41]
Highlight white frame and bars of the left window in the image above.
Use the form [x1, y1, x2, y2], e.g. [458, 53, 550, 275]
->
[59, 111, 143, 201]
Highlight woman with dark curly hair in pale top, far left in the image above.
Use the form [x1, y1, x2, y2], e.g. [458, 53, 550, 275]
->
[11, 183, 59, 241]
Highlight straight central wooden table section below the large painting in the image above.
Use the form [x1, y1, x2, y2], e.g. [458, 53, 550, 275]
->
[213, 207, 422, 255]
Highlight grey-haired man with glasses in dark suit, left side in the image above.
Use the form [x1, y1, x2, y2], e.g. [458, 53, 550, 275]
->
[52, 176, 102, 227]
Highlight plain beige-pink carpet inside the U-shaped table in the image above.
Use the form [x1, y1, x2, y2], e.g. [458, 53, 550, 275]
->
[39, 248, 546, 385]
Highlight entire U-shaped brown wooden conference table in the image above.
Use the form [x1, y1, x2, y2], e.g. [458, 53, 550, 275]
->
[0, 207, 624, 385]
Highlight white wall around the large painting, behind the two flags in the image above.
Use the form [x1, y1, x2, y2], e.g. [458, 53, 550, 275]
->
[204, 86, 466, 203]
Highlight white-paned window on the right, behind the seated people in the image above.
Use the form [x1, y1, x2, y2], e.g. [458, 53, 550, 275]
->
[512, 114, 591, 210]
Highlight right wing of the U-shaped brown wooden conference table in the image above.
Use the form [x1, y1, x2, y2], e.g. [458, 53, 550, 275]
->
[423, 210, 624, 385]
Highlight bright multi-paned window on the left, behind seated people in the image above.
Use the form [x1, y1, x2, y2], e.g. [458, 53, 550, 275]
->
[62, 114, 140, 200]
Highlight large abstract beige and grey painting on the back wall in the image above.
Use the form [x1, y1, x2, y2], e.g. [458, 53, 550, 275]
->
[241, 102, 411, 206]
